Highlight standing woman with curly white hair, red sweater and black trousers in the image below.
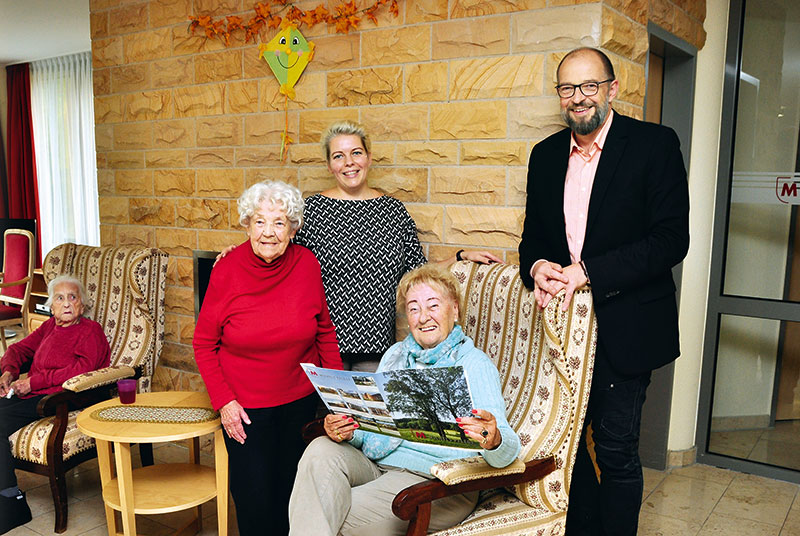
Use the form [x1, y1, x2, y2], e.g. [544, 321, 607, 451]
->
[194, 181, 342, 536]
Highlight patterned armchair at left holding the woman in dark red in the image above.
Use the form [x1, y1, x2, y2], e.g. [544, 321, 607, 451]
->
[9, 244, 168, 532]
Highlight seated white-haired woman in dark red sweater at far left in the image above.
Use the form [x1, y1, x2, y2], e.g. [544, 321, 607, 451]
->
[0, 275, 111, 534]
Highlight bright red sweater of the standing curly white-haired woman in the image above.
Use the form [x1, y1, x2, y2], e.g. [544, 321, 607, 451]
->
[193, 241, 342, 409]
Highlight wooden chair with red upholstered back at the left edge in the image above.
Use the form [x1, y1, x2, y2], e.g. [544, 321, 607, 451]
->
[0, 229, 36, 352]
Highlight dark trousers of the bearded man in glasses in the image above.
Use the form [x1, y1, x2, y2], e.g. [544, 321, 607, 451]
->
[566, 372, 650, 536]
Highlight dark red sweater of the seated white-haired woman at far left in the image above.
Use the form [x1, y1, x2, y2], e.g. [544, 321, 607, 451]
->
[0, 317, 111, 398]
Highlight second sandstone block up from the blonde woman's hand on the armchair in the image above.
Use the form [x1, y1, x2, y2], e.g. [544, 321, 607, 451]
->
[430, 165, 506, 206]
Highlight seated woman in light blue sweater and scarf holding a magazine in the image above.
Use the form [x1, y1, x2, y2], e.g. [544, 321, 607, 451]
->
[289, 264, 520, 536]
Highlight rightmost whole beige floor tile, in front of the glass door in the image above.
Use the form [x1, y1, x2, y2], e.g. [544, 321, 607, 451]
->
[714, 475, 798, 527]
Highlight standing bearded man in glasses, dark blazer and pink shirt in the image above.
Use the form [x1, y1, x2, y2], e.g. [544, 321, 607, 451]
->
[519, 48, 689, 536]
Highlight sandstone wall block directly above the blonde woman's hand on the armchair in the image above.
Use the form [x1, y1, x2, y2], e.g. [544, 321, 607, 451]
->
[445, 206, 525, 248]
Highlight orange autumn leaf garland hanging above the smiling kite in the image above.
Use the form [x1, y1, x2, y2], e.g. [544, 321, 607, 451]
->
[189, 0, 399, 46]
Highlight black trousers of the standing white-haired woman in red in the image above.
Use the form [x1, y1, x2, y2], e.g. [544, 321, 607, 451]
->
[225, 393, 319, 536]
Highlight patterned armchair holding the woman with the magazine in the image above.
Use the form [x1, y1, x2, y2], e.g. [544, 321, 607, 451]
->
[392, 262, 597, 536]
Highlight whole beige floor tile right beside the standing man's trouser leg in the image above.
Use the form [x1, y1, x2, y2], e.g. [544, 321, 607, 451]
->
[642, 475, 725, 525]
